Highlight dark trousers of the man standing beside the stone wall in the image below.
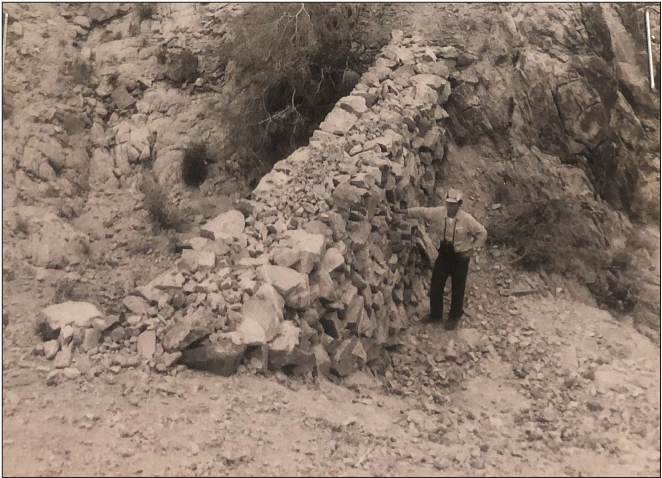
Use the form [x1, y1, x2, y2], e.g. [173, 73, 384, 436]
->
[430, 244, 470, 321]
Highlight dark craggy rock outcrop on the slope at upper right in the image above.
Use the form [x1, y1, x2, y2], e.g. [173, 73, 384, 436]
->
[448, 4, 660, 219]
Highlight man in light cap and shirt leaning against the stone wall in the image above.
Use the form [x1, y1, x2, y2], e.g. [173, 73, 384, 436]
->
[406, 189, 487, 330]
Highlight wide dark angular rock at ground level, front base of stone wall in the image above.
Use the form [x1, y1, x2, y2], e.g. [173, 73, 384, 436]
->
[179, 337, 246, 377]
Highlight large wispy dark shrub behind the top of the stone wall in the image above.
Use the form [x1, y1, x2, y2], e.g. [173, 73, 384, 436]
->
[222, 3, 378, 171]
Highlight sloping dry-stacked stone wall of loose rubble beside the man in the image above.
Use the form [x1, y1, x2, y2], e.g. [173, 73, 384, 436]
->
[36, 31, 458, 376]
